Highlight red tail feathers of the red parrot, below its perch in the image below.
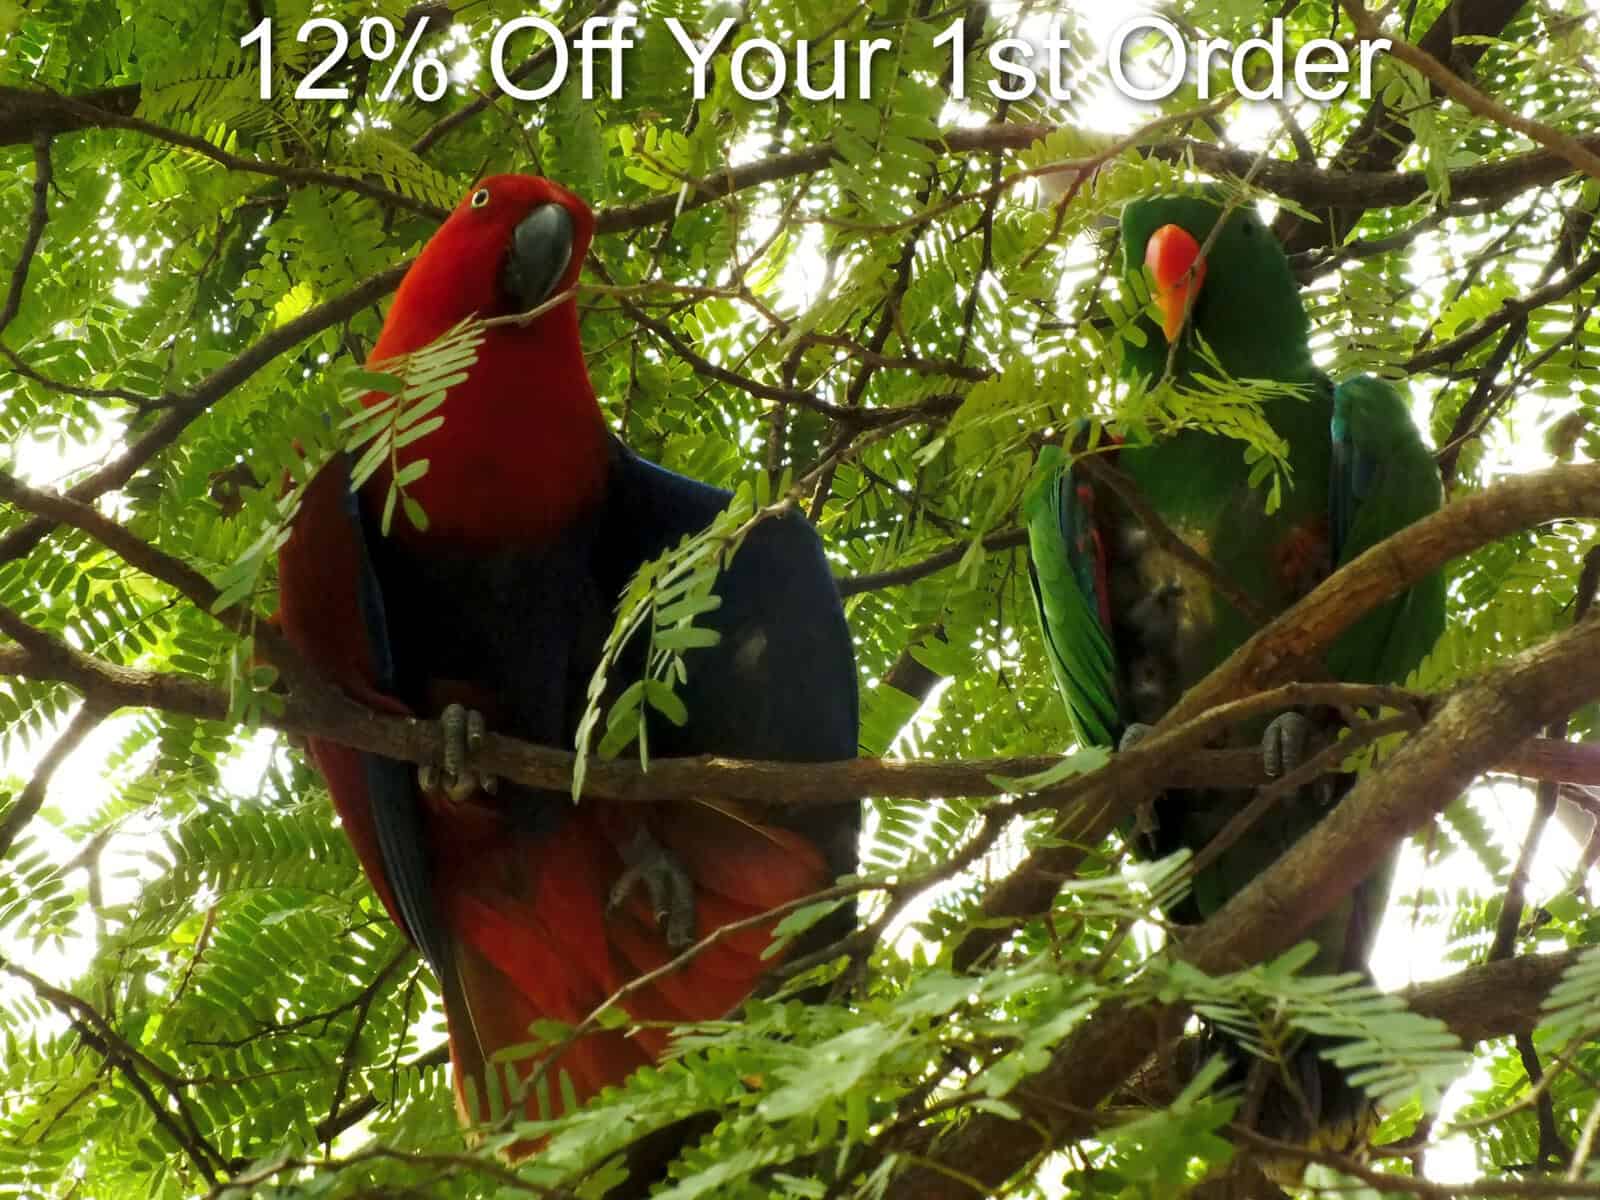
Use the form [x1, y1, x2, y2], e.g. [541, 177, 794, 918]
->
[434, 802, 830, 1115]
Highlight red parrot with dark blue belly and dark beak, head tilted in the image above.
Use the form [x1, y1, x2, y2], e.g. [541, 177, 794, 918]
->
[278, 176, 859, 1145]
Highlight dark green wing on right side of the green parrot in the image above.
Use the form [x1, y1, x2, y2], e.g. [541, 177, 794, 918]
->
[1328, 374, 1445, 683]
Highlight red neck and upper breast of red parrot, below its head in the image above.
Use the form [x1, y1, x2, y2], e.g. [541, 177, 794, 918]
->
[363, 302, 610, 549]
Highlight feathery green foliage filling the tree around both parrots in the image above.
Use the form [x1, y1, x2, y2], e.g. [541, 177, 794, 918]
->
[0, 0, 1600, 1200]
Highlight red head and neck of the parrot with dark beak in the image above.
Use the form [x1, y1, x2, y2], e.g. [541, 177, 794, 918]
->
[365, 174, 610, 547]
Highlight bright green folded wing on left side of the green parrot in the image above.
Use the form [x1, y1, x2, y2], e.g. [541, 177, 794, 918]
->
[1022, 446, 1122, 746]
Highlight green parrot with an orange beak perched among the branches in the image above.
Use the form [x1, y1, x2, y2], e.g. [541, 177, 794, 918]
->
[1024, 192, 1445, 1149]
